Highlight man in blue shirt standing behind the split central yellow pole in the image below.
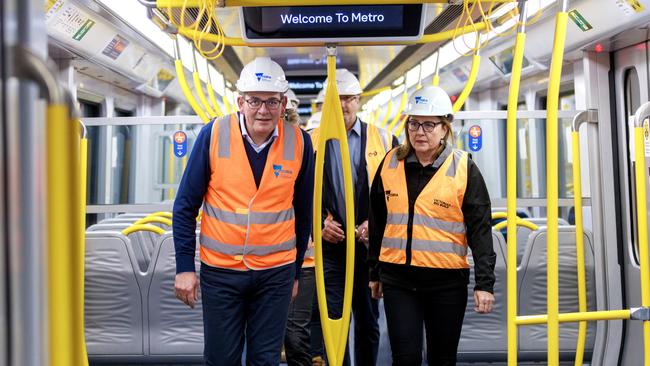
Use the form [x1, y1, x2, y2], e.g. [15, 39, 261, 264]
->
[311, 69, 397, 366]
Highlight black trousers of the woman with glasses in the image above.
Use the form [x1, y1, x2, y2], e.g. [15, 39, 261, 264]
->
[384, 284, 467, 366]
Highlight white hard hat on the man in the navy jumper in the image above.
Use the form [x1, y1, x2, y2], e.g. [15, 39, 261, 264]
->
[237, 57, 289, 93]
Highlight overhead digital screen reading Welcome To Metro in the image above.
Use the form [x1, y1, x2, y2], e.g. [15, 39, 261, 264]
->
[242, 4, 423, 41]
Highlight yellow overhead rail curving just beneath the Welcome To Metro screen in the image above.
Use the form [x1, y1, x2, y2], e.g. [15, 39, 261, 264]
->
[178, 22, 484, 47]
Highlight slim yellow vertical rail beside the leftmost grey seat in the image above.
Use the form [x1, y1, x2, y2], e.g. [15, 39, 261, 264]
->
[75, 120, 88, 366]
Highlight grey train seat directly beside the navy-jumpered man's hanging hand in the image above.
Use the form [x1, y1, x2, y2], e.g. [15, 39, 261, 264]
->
[146, 233, 203, 356]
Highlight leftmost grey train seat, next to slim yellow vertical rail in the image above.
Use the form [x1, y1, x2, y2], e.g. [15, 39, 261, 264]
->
[84, 231, 146, 356]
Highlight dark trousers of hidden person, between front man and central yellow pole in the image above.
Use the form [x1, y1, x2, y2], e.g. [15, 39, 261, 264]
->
[284, 267, 316, 366]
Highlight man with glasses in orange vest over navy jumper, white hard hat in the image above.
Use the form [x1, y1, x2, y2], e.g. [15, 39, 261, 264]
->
[173, 57, 314, 366]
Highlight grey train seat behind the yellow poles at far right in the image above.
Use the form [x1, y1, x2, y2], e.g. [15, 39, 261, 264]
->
[517, 226, 596, 361]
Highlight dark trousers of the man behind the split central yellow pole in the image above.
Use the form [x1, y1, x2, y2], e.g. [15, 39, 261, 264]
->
[323, 243, 379, 366]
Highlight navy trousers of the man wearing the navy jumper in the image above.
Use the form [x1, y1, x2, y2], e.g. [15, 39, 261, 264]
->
[201, 263, 295, 366]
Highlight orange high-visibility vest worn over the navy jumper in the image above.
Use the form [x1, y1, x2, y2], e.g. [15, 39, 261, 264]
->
[200, 114, 303, 270]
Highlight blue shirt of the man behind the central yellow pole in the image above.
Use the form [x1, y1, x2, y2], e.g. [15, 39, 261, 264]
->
[328, 118, 362, 217]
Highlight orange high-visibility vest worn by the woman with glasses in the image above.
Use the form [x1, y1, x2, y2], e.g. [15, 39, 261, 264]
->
[379, 147, 469, 268]
